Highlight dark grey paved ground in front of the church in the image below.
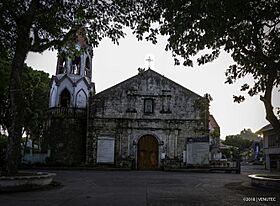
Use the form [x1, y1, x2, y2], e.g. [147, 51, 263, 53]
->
[0, 166, 280, 206]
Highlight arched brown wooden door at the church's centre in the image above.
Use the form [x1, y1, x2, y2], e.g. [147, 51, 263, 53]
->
[137, 135, 158, 170]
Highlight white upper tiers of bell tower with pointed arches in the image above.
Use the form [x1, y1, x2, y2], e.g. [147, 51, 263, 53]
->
[49, 28, 95, 108]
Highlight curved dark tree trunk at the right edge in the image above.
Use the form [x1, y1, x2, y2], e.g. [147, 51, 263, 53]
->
[260, 75, 280, 133]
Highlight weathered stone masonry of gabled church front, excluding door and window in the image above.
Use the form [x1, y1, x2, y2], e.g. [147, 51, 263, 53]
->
[87, 70, 208, 167]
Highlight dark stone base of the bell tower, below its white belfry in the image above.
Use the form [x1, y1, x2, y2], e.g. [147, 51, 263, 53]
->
[43, 108, 86, 165]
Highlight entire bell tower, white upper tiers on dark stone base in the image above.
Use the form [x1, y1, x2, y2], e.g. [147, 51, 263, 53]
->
[43, 28, 95, 165]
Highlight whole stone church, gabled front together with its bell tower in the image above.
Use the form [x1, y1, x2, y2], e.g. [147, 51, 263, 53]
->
[43, 30, 209, 170]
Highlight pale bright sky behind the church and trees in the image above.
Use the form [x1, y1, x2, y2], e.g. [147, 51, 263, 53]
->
[26, 30, 280, 139]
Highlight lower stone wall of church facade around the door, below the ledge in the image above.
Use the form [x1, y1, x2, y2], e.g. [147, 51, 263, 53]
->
[88, 116, 208, 166]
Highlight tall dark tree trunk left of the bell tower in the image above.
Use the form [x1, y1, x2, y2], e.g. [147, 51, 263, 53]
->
[2, 26, 31, 175]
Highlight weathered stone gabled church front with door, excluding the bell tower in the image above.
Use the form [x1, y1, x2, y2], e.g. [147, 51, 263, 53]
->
[87, 69, 209, 169]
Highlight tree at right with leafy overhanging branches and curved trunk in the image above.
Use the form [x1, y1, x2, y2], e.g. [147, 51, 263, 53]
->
[135, 0, 280, 133]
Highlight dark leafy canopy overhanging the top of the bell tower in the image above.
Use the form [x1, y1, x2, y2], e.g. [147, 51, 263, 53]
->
[0, 0, 140, 56]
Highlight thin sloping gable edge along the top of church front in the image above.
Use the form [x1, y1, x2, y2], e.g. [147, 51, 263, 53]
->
[95, 68, 203, 98]
